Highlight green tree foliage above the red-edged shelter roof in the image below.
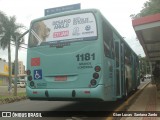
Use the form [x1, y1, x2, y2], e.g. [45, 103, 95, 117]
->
[130, 0, 160, 19]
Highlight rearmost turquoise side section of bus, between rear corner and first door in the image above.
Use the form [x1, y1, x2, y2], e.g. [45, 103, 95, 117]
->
[102, 18, 116, 101]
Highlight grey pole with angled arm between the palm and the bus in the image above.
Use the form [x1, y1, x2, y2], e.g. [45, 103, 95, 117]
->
[14, 30, 29, 96]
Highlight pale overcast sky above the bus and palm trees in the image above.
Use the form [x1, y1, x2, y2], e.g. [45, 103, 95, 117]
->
[0, 0, 147, 65]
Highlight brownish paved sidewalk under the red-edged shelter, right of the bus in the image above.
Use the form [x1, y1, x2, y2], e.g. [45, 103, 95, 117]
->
[121, 83, 160, 120]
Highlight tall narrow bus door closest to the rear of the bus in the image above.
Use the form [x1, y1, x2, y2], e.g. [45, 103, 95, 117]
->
[115, 41, 122, 98]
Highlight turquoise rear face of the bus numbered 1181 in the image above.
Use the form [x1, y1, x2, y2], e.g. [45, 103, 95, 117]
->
[26, 10, 103, 100]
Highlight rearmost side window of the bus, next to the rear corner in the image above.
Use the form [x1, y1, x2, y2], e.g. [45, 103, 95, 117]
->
[102, 21, 114, 58]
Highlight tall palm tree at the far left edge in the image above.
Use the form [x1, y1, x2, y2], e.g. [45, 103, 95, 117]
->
[0, 11, 24, 92]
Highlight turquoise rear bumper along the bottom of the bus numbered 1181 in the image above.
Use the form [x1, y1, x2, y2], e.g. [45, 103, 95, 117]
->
[26, 85, 104, 101]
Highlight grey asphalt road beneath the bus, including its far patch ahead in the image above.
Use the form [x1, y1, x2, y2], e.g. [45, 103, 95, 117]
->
[0, 80, 148, 120]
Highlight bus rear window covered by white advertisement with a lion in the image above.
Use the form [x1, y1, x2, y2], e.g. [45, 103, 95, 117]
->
[29, 13, 97, 47]
